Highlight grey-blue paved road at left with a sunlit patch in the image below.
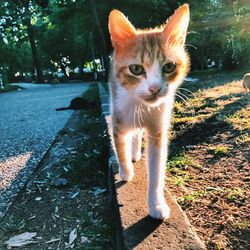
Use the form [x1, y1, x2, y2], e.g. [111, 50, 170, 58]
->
[0, 83, 93, 218]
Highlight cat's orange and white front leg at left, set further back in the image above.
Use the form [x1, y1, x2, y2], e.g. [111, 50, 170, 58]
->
[113, 130, 134, 181]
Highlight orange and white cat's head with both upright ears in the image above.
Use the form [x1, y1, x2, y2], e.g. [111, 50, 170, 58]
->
[109, 4, 189, 106]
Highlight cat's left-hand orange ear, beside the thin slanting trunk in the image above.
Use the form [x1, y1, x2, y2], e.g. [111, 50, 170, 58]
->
[109, 10, 136, 47]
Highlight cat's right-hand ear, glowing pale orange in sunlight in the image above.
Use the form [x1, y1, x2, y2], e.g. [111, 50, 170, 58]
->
[163, 4, 190, 47]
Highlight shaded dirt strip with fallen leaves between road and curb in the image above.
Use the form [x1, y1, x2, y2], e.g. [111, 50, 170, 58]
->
[0, 87, 113, 250]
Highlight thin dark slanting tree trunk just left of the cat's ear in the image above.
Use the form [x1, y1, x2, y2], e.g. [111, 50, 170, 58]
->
[90, 0, 109, 81]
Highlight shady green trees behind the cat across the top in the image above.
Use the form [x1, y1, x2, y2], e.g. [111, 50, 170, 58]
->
[0, 0, 250, 83]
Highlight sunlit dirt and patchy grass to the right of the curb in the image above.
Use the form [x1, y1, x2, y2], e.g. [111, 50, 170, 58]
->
[167, 73, 250, 250]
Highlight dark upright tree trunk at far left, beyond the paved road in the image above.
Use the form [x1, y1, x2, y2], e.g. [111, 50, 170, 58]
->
[27, 18, 43, 83]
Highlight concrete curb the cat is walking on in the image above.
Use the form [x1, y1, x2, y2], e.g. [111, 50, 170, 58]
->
[99, 83, 206, 250]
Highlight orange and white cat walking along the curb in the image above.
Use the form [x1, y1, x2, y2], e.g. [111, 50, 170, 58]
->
[109, 4, 190, 219]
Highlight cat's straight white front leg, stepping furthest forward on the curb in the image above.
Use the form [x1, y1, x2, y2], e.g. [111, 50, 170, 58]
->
[147, 131, 170, 219]
